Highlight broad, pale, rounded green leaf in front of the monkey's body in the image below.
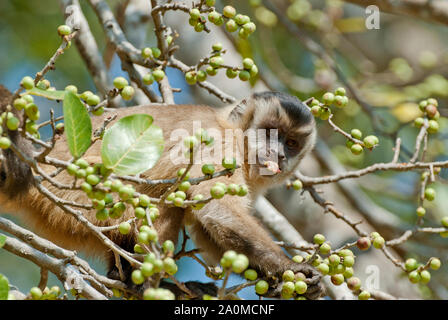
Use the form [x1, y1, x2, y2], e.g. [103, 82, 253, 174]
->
[101, 114, 164, 175]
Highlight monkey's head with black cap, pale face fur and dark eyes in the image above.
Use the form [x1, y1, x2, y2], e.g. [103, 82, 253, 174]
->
[229, 92, 316, 190]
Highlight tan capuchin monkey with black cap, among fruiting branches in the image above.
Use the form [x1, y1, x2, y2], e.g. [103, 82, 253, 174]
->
[0, 86, 323, 299]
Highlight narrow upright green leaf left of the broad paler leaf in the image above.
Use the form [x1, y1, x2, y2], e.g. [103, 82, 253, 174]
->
[63, 91, 92, 158]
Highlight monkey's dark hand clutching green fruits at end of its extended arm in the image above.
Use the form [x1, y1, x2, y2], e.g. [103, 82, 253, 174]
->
[265, 263, 325, 300]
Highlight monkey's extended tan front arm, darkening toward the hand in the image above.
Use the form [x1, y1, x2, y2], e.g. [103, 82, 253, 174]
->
[189, 197, 323, 298]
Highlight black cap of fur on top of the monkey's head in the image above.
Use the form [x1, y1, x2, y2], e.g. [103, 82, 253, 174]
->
[252, 91, 314, 126]
